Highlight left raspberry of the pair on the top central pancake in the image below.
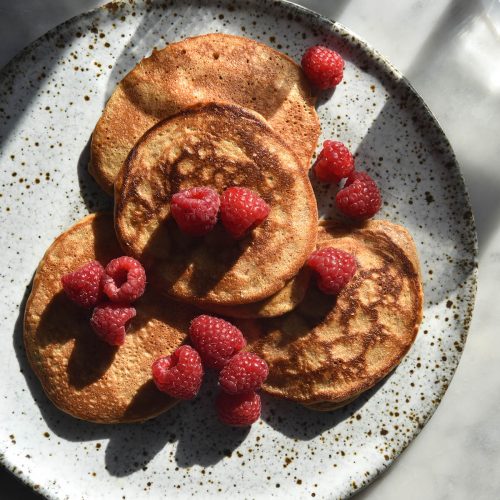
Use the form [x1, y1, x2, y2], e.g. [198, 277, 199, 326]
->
[170, 187, 220, 236]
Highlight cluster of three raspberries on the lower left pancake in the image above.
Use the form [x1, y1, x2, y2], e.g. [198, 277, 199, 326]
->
[61, 256, 146, 346]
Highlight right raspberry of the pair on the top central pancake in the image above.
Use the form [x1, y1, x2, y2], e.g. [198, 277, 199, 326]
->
[220, 187, 270, 239]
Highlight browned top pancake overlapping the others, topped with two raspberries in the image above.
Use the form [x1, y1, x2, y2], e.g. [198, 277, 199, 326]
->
[115, 103, 318, 306]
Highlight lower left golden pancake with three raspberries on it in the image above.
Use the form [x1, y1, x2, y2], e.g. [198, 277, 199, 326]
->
[24, 213, 197, 423]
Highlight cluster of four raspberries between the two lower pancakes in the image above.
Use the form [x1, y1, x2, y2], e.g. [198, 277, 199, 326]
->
[152, 314, 269, 426]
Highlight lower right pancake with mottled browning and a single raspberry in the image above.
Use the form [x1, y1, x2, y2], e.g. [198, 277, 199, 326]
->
[242, 221, 423, 411]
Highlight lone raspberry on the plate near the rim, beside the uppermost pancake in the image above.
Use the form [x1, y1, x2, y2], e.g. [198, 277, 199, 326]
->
[302, 45, 344, 90]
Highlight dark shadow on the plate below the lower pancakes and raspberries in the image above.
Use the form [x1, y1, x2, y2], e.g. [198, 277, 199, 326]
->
[13, 280, 365, 477]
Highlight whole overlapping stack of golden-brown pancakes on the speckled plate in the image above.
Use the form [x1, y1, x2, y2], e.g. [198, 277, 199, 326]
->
[25, 34, 422, 423]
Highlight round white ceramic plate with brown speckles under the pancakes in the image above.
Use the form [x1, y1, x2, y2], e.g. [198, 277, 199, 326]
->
[0, 0, 477, 499]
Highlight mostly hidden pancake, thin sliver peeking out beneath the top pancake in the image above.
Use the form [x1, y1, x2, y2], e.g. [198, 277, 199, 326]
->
[200, 267, 311, 319]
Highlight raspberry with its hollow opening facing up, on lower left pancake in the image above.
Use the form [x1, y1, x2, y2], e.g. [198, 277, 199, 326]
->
[101, 256, 146, 304]
